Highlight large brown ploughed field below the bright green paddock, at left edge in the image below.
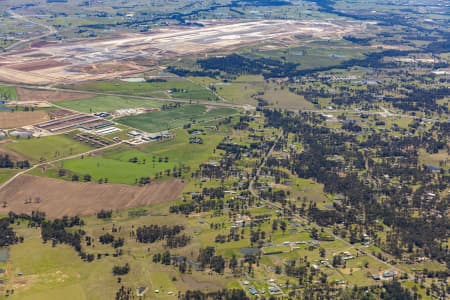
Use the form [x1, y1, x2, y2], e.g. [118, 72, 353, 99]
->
[0, 175, 184, 219]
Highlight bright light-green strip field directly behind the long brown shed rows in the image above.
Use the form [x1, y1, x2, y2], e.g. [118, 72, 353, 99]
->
[56, 96, 162, 113]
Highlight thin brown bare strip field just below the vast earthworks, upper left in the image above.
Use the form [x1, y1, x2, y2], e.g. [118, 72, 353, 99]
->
[17, 88, 94, 102]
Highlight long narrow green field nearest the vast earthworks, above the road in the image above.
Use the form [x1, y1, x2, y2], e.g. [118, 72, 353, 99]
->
[66, 79, 216, 100]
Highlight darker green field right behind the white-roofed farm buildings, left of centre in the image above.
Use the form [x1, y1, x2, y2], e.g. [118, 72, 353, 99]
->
[116, 105, 237, 132]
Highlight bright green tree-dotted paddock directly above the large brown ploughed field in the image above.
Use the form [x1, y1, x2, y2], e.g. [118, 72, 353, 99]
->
[38, 130, 224, 184]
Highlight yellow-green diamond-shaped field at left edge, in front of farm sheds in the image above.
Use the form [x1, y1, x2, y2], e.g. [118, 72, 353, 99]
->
[2, 134, 93, 162]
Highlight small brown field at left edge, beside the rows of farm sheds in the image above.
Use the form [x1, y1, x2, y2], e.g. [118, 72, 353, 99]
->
[0, 111, 50, 129]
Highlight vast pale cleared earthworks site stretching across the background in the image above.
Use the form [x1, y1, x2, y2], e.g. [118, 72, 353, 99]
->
[0, 20, 366, 85]
